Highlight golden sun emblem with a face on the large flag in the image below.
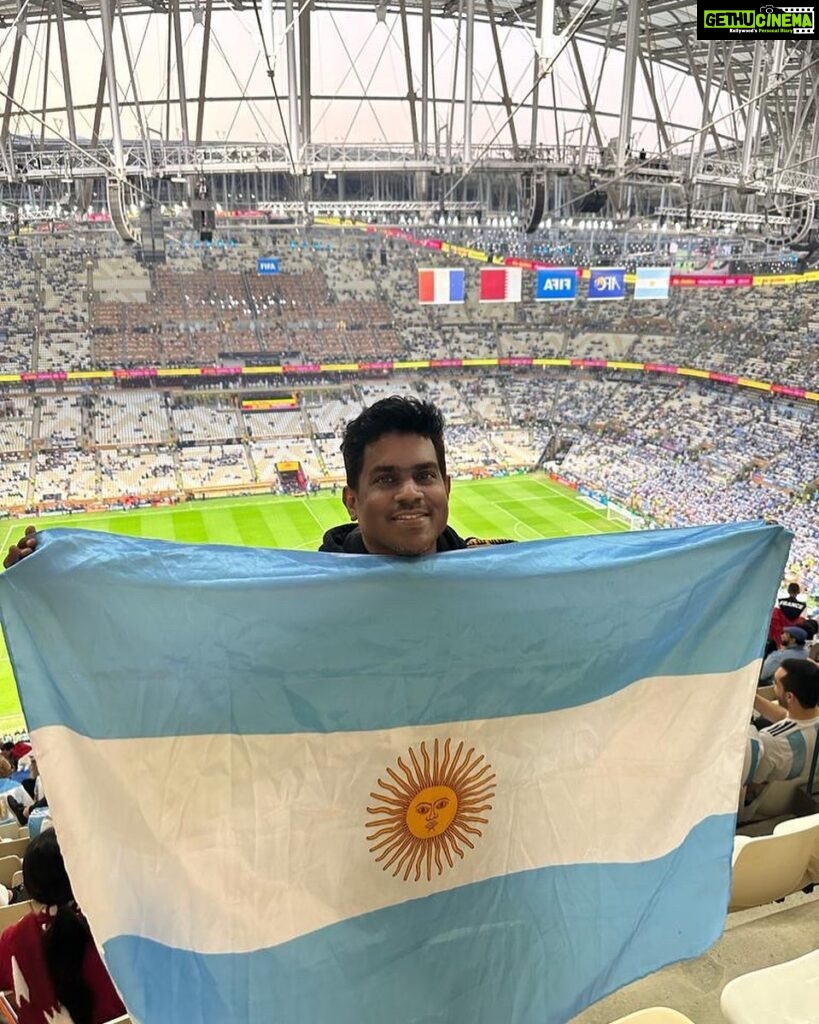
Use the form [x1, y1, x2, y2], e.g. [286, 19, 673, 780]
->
[367, 739, 495, 882]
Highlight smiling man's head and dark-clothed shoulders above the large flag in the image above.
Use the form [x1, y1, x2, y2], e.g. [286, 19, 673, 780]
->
[319, 395, 506, 557]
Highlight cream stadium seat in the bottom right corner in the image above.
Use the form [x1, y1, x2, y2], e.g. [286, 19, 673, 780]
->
[720, 949, 819, 1024]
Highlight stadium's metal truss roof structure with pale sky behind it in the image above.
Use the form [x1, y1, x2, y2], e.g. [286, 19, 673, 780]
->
[0, 0, 819, 242]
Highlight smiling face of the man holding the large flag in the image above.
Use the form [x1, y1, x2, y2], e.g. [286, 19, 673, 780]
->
[344, 434, 450, 556]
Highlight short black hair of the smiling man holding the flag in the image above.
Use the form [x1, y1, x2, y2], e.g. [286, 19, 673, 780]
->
[341, 394, 446, 490]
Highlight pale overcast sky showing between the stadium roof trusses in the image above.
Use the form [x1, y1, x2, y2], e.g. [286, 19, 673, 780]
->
[0, 11, 728, 151]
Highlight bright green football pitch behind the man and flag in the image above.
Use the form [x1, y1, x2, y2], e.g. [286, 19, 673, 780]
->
[0, 475, 626, 732]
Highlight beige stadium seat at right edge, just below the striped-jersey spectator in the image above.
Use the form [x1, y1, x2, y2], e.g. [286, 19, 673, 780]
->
[728, 814, 819, 910]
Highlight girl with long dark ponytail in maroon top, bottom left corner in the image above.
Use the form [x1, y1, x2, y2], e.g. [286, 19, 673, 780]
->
[0, 828, 125, 1024]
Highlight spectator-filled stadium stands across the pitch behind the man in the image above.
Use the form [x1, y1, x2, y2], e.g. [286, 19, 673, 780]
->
[0, 228, 819, 592]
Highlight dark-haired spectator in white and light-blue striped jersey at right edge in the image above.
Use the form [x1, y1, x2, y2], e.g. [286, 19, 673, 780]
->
[744, 658, 819, 803]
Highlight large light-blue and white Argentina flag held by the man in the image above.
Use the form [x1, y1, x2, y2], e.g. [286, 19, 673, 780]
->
[0, 523, 790, 1024]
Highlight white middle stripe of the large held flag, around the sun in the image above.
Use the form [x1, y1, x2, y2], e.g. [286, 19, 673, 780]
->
[33, 660, 760, 952]
